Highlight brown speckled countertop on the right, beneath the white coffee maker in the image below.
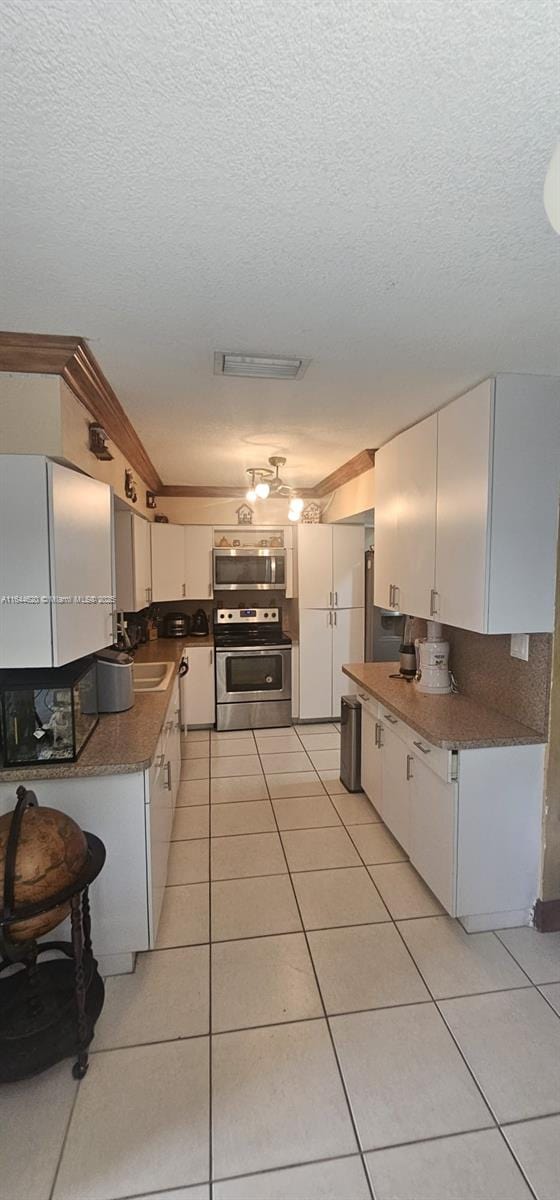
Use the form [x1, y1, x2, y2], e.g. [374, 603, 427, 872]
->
[342, 662, 547, 750]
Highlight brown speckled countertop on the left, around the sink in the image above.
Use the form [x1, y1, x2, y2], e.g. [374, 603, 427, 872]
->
[0, 637, 213, 784]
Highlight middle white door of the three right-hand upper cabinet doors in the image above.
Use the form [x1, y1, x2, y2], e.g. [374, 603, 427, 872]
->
[395, 413, 438, 617]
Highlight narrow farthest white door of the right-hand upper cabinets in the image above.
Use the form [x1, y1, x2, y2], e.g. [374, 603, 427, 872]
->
[373, 438, 401, 608]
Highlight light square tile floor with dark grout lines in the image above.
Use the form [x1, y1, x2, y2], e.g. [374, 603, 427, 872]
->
[5, 724, 560, 1200]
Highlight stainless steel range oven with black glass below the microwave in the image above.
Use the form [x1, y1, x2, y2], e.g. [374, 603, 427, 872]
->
[213, 608, 291, 730]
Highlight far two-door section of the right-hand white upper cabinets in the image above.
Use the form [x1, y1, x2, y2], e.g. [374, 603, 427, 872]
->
[374, 414, 438, 617]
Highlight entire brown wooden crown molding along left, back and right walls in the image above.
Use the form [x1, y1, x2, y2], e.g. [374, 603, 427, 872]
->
[0, 332, 375, 499]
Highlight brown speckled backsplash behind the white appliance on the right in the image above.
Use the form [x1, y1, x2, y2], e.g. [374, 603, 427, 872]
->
[413, 619, 553, 733]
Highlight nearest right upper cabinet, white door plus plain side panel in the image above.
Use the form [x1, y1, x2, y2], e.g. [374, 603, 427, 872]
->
[435, 376, 560, 634]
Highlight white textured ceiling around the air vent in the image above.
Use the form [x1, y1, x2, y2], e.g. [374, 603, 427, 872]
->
[0, 0, 560, 484]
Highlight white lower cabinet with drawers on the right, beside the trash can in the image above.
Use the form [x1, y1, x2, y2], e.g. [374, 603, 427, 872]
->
[360, 695, 546, 932]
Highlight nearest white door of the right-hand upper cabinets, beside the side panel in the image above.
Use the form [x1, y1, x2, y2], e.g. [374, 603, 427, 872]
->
[435, 379, 494, 634]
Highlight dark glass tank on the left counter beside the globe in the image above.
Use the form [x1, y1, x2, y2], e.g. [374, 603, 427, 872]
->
[0, 658, 98, 767]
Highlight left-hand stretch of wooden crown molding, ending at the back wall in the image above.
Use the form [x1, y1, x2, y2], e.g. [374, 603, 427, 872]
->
[0, 332, 163, 492]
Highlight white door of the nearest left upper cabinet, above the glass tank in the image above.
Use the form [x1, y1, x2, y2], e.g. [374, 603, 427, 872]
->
[47, 462, 113, 666]
